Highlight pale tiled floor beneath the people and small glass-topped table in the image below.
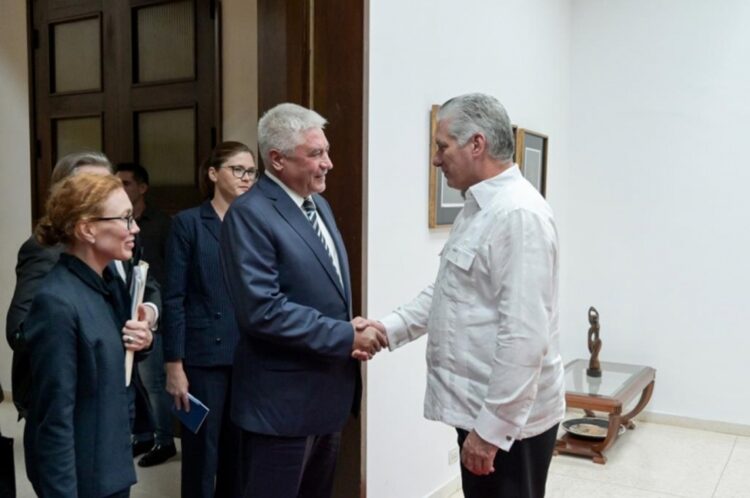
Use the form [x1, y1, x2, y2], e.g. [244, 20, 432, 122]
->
[0, 402, 750, 498]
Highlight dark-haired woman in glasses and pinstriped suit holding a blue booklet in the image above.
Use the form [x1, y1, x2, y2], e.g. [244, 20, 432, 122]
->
[163, 142, 258, 498]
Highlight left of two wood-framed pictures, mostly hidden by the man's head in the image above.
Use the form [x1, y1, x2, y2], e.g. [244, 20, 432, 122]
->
[429, 105, 518, 228]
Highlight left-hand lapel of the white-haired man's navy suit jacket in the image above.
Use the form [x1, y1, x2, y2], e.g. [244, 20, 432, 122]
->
[256, 177, 348, 302]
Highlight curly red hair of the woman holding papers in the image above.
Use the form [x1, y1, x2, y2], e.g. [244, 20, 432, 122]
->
[34, 173, 122, 246]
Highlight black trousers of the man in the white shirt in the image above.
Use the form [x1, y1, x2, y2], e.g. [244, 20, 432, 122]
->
[456, 424, 560, 498]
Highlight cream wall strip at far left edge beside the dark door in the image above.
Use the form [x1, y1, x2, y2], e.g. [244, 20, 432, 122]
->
[0, 0, 31, 391]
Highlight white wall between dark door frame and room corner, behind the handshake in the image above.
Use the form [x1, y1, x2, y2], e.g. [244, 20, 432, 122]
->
[367, 0, 570, 498]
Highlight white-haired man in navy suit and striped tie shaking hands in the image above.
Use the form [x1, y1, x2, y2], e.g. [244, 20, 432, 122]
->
[221, 104, 386, 498]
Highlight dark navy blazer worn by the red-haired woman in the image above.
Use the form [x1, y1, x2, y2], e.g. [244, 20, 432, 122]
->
[23, 254, 136, 498]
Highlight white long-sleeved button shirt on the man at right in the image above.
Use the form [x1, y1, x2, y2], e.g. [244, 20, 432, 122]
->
[381, 165, 565, 451]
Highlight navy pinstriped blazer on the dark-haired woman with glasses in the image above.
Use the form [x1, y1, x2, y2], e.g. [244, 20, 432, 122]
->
[162, 201, 239, 366]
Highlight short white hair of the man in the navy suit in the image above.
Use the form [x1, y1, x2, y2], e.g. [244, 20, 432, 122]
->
[258, 103, 328, 168]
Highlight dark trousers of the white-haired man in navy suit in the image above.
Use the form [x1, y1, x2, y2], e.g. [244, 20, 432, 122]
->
[241, 431, 341, 498]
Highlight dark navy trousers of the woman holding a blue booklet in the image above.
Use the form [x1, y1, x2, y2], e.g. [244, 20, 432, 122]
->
[181, 365, 241, 498]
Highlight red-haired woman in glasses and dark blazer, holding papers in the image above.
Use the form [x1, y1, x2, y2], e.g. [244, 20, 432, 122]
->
[23, 173, 153, 498]
